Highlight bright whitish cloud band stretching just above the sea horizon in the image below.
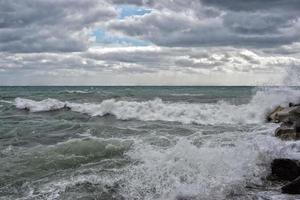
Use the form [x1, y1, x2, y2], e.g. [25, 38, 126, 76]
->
[0, 46, 300, 85]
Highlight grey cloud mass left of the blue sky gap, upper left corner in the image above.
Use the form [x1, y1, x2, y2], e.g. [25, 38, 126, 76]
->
[0, 0, 116, 52]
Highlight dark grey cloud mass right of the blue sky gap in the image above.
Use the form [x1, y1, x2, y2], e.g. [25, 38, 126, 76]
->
[108, 0, 300, 48]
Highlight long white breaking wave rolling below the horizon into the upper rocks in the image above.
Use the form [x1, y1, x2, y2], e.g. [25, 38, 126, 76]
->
[15, 88, 300, 124]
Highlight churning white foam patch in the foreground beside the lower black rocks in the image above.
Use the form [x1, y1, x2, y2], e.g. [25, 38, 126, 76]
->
[119, 136, 277, 200]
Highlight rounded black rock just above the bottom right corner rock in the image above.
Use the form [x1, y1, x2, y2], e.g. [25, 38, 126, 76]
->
[271, 159, 300, 181]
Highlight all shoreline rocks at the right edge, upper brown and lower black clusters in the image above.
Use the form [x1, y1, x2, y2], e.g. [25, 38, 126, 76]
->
[266, 103, 300, 194]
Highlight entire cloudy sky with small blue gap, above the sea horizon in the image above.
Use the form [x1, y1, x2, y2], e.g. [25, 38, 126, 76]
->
[0, 0, 300, 85]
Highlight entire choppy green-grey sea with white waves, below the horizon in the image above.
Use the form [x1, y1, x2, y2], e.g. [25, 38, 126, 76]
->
[0, 87, 300, 200]
